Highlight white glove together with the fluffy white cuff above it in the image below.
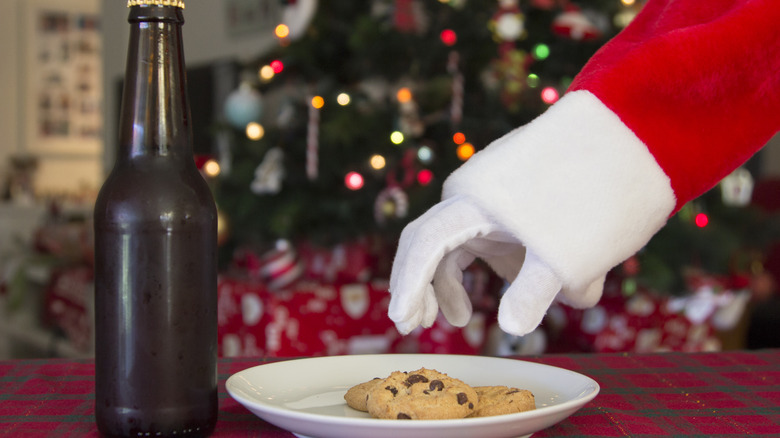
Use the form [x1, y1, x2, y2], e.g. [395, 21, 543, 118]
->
[388, 91, 675, 335]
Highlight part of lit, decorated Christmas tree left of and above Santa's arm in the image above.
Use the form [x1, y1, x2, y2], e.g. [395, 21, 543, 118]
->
[210, 0, 624, 264]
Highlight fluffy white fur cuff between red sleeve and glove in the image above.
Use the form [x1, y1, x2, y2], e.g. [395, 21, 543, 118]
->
[443, 91, 675, 289]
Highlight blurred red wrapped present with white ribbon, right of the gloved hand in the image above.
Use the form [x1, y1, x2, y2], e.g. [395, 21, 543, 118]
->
[545, 277, 750, 352]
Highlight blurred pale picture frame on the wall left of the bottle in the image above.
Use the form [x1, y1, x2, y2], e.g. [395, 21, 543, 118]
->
[19, 0, 104, 157]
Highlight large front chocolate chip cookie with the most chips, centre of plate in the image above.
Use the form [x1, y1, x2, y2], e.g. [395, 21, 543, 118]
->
[366, 368, 479, 420]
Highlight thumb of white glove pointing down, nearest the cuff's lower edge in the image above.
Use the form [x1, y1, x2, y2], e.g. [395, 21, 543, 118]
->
[498, 252, 562, 336]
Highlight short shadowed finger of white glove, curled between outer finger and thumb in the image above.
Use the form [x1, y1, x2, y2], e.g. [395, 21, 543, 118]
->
[433, 249, 475, 327]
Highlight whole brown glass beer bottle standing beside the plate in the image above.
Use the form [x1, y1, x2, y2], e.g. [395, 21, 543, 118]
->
[94, 1, 217, 437]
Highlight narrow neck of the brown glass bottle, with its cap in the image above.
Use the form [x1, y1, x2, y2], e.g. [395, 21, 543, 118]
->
[117, 6, 192, 160]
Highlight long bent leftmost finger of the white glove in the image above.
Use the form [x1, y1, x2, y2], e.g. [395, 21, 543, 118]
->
[388, 197, 491, 323]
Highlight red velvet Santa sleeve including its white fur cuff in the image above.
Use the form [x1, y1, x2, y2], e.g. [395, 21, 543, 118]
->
[443, 0, 780, 296]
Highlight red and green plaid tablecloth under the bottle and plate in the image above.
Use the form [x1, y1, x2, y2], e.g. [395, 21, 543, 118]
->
[0, 350, 780, 438]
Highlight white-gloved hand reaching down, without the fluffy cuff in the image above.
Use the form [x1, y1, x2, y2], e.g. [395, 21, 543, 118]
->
[389, 196, 603, 335]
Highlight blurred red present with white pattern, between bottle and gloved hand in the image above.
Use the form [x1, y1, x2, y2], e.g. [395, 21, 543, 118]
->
[219, 277, 495, 357]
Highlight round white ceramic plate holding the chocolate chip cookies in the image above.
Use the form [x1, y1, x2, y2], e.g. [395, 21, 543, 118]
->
[226, 354, 599, 438]
